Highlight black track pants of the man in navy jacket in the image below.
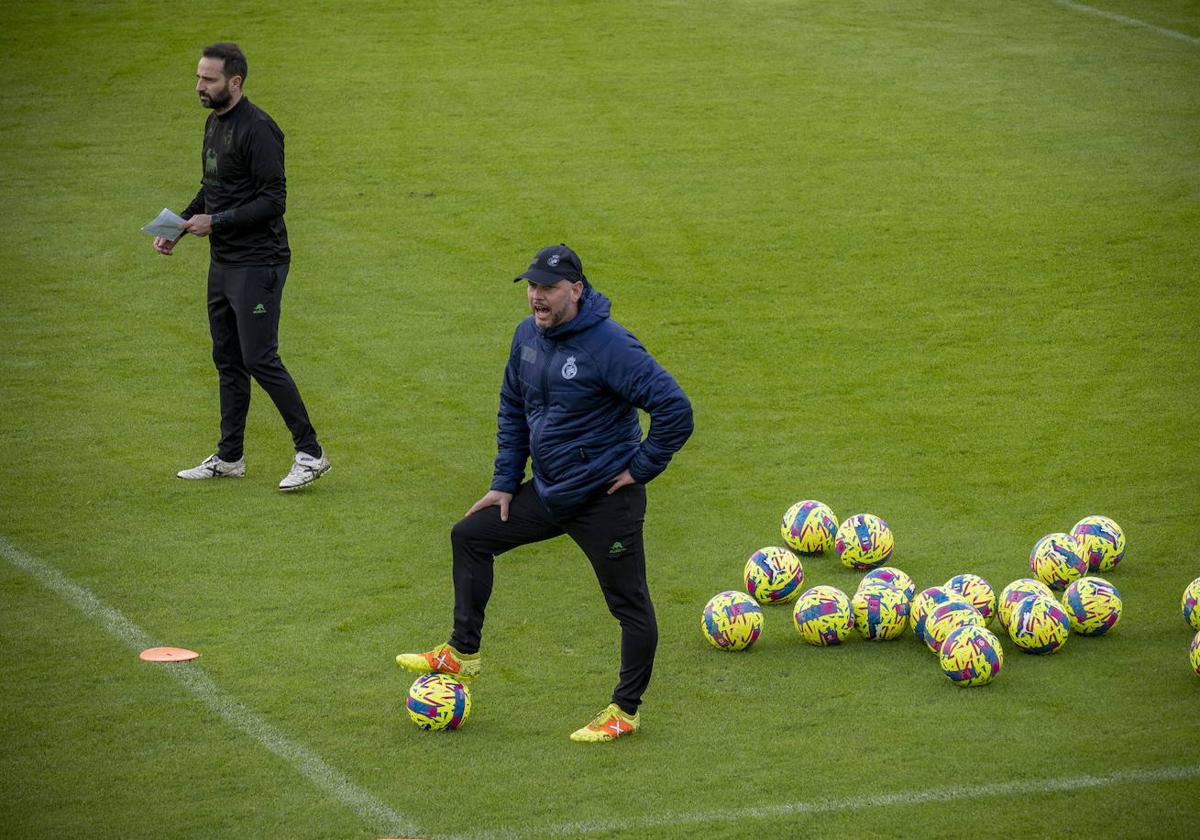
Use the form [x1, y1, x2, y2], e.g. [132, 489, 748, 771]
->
[450, 482, 659, 713]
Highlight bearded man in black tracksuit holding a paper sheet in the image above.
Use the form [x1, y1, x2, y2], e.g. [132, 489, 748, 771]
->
[155, 43, 329, 491]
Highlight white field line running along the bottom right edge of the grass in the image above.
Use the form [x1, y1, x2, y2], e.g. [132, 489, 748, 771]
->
[458, 763, 1200, 840]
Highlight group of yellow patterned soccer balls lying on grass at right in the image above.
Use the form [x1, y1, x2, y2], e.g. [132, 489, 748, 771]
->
[701, 500, 1137, 686]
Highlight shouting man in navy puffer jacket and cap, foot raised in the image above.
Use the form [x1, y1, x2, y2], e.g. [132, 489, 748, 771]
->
[396, 245, 692, 742]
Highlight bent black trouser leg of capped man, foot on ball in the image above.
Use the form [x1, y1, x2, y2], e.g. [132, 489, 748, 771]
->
[450, 482, 563, 653]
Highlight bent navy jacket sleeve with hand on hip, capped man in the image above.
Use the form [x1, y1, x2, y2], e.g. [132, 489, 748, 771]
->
[610, 336, 695, 488]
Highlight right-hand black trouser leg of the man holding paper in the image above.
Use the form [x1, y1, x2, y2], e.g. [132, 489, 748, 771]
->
[223, 264, 320, 457]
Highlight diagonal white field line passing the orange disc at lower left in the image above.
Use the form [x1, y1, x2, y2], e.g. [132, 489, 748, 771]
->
[0, 536, 419, 835]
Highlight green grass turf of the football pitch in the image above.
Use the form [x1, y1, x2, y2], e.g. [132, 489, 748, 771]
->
[0, 0, 1200, 838]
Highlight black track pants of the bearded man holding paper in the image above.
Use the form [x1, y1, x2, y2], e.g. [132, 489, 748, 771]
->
[209, 263, 320, 461]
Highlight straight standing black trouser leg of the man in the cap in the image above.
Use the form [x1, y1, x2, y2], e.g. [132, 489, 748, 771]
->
[566, 485, 659, 714]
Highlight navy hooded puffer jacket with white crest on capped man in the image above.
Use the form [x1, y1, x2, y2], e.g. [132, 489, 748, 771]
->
[492, 286, 692, 518]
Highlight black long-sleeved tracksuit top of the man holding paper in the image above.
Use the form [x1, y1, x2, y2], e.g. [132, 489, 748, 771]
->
[181, 96, 292, 265]
